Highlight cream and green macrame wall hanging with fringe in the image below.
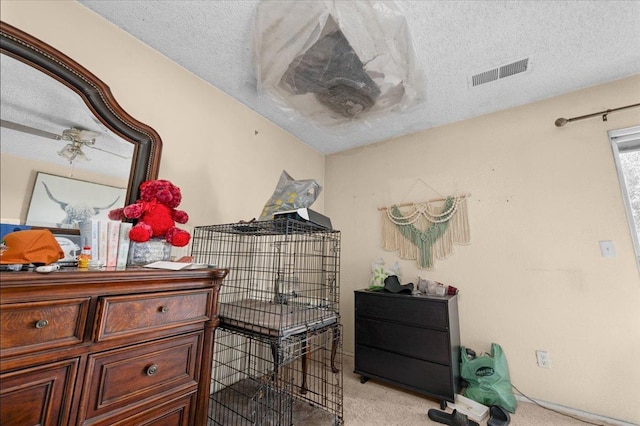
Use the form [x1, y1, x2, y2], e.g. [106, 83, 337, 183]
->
[379, 183, 471, 269]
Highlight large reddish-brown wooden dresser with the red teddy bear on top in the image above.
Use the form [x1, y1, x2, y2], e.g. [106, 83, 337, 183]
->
[0, 268, 227, 426]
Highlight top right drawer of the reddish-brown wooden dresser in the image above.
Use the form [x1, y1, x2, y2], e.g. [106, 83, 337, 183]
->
[95, 289, 213, 341]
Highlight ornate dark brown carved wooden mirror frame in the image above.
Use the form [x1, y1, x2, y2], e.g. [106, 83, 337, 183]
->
[0, 21, 162, 205]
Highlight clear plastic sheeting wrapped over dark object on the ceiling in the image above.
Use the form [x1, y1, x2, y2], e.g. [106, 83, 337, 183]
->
[254, 0, 421, 127]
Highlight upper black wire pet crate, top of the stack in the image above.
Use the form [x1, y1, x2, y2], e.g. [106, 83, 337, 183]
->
[192, 218, 340, 337]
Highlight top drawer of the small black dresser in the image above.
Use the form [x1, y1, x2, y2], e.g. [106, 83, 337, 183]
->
[355, 292, 449, 330]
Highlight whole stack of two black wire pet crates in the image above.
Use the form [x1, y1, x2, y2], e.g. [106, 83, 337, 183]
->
[191, 218, 343, 426]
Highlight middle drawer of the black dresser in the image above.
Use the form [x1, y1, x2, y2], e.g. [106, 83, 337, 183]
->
[356, 318, 451, 365]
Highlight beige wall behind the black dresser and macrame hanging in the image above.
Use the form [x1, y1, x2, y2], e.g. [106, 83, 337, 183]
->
[326, 75, 640, 422]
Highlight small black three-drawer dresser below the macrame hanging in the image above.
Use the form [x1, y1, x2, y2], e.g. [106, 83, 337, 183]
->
[355, 290, 460, 409]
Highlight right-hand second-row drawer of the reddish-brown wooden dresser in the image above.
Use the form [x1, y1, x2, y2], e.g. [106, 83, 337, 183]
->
[83, 332, 203, 419]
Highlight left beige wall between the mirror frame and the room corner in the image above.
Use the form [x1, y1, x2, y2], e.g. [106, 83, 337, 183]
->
[0, 0, 324, 230]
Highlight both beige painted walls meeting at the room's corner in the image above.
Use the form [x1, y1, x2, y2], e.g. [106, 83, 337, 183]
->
[0, 0, 640, 422]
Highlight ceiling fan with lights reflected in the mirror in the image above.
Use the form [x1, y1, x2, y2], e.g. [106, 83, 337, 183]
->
[0, 120, 131, 164]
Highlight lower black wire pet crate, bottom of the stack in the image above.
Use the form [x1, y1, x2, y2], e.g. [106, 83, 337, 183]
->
[208, 324, 343, 426]
